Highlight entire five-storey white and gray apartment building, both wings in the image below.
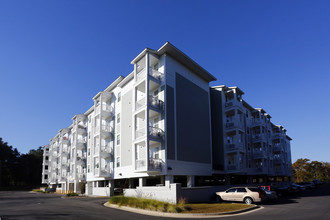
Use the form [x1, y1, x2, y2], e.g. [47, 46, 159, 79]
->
[42, 42, 291, 202]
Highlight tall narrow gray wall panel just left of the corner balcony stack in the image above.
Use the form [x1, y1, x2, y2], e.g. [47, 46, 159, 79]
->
[120, 90, 133, 166]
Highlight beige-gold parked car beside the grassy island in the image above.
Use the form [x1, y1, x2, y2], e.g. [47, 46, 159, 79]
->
[216, 187, 266, 204]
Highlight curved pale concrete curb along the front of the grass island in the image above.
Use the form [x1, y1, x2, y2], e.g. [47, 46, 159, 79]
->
[104, 202, 263, 218]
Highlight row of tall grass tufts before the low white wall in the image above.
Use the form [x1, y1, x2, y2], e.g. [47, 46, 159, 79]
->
[109, 196, 184, 213]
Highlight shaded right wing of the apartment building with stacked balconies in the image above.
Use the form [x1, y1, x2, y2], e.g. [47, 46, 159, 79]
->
[211, 86, 292, 183]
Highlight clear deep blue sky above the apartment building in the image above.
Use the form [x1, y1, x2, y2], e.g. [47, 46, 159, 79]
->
[0, 0, 330, 162]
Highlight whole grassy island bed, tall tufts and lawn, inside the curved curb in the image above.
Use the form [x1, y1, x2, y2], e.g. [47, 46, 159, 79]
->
[109, 196, 253, 213]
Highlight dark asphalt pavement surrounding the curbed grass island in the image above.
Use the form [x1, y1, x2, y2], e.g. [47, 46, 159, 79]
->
[0, 185, 330, 220]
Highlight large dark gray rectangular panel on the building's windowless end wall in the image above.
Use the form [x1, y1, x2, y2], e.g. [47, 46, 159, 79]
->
[175, 73, 211, 163]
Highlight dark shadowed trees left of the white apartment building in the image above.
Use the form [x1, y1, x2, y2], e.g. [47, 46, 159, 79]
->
[0, 138, 43, 190]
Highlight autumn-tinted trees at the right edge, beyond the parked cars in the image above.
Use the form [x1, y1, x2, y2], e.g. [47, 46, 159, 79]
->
[292, 158, 330, 182]
